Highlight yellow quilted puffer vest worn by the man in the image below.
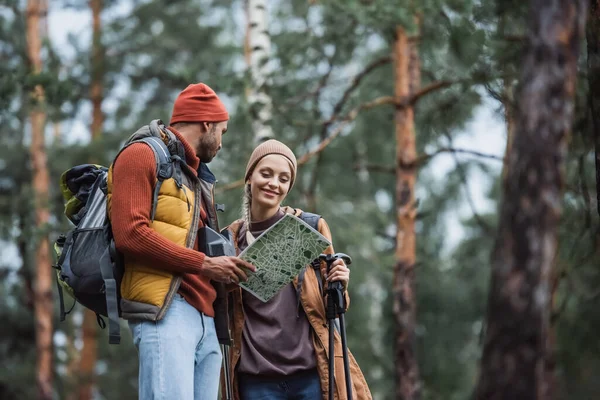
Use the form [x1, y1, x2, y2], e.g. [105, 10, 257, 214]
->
[107, 122, 204, 321]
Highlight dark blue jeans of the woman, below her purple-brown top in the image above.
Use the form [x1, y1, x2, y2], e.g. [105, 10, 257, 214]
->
[238, 368, 322, 400]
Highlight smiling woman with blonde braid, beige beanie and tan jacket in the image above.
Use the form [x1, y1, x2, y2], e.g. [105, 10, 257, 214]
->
[229, 140, 371, 400]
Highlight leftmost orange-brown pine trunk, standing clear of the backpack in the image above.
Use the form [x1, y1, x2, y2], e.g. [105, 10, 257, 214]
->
[27, 0, 53, 399]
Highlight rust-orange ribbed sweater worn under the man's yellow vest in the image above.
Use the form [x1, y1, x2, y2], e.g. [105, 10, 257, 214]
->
[110, 128, 216, 317]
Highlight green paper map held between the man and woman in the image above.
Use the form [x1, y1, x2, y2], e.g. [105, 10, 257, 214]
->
[239, 214, 331, 302]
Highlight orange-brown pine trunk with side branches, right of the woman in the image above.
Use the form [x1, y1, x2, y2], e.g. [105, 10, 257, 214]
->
[393, 27, 420, 400]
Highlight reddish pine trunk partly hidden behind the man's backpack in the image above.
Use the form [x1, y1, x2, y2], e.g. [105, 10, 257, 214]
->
[77, 0, 104, 400]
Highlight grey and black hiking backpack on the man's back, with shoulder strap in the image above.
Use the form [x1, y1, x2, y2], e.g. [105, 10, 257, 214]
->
[53, 120, 185, 344]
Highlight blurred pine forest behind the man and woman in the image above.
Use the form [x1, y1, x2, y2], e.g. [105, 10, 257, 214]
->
[0, 0, 600, 400]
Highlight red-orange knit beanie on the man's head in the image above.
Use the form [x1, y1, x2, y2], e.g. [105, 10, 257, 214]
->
[171, 83, 229, 125]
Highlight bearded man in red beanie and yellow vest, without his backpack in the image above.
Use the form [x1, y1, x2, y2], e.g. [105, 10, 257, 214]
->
[108, 83, 255, 400]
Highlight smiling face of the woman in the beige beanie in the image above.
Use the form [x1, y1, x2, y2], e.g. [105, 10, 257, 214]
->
[248, 154, 292, 209]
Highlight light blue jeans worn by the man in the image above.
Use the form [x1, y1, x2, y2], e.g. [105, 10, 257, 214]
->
[129, 294, 222, 400]
